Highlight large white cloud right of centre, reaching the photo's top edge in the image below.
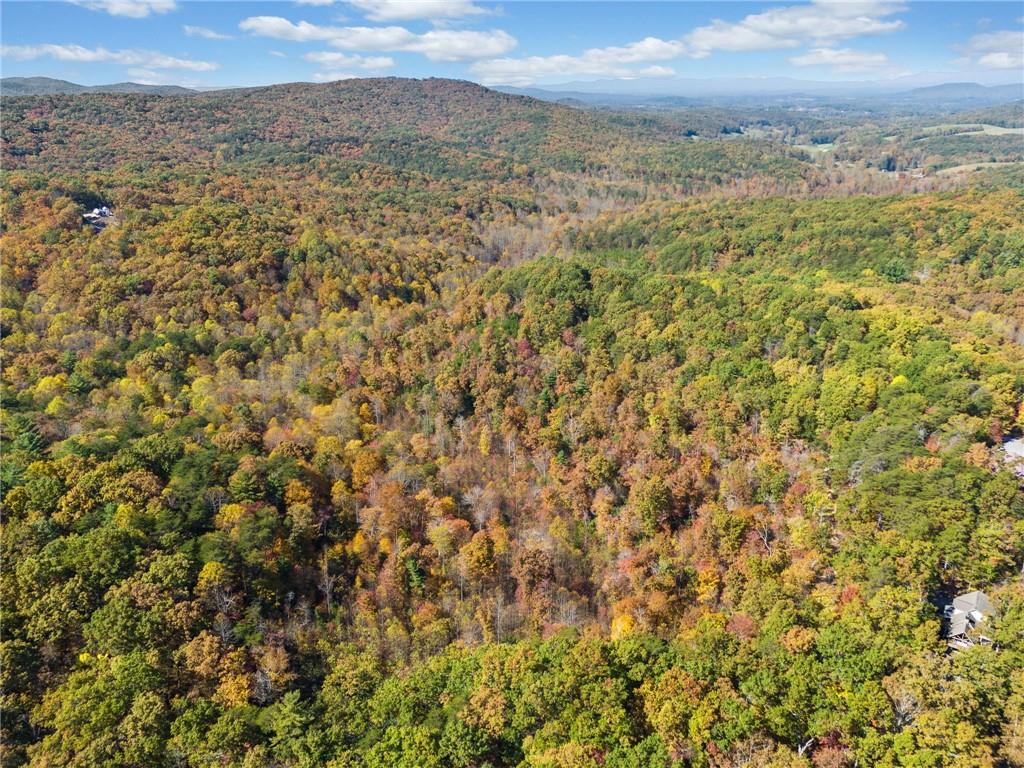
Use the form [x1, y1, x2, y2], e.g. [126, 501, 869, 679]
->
[683, 0, 904, 58]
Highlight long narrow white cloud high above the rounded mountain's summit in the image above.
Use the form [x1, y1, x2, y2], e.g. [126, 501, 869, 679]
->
[239, 16, 516, 61]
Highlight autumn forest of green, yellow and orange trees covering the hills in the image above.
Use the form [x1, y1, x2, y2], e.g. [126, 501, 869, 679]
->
[0, 79, 1024, 768]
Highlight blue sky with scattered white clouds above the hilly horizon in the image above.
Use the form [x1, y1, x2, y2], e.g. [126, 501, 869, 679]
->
[0, 0, 1024, 87]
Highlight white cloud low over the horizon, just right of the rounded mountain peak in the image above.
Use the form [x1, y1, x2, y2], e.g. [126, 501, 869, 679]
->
[470, 37, 686, 85]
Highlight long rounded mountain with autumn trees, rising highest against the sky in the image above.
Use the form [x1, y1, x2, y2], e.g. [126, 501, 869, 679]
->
[4, 78, 811, 184]
